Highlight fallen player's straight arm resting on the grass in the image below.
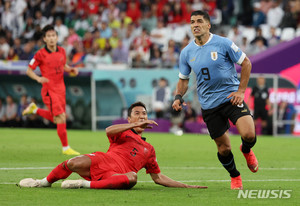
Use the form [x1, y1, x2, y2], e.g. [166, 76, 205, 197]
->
[150, 173, 207, 189]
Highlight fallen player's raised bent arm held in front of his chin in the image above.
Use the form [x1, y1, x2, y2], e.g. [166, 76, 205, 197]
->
[105, 120, 158, 137]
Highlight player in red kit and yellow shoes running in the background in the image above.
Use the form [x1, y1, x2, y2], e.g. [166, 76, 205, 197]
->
[22, 25, 80, 155]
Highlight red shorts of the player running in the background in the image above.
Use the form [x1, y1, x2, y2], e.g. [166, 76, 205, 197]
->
[41, 88, 66, 116]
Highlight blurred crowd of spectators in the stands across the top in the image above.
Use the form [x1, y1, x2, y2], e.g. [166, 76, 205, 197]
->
[0, 0, 300, 69]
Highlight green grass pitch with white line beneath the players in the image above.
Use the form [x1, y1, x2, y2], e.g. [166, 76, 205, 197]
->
[0, 129, 300, 206]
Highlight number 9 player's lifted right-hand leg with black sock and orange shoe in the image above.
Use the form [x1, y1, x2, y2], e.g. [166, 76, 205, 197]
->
[236, 115, 258, 172]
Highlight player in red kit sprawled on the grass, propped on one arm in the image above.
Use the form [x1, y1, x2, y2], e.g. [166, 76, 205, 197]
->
[19, 102, 207, 189]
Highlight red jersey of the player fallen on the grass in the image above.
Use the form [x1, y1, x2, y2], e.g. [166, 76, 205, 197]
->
[106, 130, 160, 174]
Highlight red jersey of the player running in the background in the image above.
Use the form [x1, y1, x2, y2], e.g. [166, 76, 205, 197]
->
[28, 46, 66, 93]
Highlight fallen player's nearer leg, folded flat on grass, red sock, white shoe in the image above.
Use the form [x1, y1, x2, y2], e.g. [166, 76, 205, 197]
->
[61, 172, 137, 189]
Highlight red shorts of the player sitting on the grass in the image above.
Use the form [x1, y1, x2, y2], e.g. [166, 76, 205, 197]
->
[85, 152, 121, 181]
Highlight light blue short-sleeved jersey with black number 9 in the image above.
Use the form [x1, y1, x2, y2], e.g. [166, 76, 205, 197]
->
[179, 34, 246, 109]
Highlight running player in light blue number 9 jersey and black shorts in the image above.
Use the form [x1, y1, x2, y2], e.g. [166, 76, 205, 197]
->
[172, 11, 258, 189]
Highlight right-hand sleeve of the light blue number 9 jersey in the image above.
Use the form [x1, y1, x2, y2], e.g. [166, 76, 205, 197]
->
[225, 39, 246, 65]
